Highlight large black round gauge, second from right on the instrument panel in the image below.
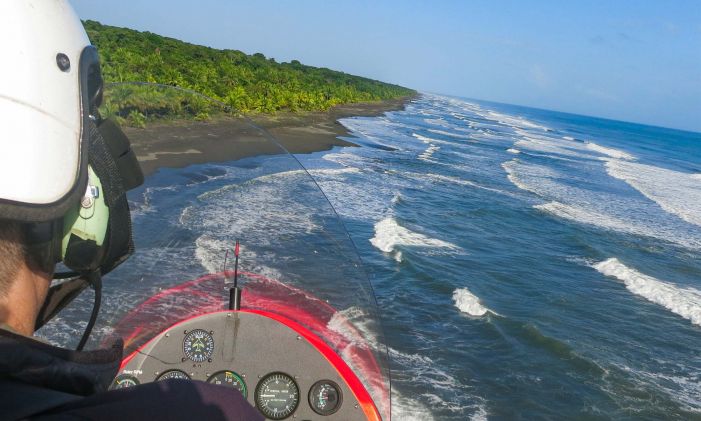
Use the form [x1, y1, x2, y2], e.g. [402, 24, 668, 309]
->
[256, 373, 299, 420]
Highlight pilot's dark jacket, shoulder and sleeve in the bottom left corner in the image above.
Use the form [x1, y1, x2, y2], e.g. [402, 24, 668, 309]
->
[0, 329, 263, 421]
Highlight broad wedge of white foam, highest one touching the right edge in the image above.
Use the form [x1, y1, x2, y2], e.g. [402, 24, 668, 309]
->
[606, 160, 701, 225]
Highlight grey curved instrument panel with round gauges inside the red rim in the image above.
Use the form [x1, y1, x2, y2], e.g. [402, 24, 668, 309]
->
[112, 311, 365, 420]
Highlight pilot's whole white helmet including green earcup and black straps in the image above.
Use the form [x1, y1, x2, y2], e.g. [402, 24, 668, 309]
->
[0, 0, 143, 338]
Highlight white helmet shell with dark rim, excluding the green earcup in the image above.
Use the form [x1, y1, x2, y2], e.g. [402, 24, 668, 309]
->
[0, 0, 101, 222]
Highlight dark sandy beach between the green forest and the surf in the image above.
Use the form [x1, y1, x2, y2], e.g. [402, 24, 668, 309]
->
[124, 96, 416, 177]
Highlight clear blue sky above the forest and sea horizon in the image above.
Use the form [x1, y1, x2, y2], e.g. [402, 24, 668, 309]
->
[72, 0, 701, 132]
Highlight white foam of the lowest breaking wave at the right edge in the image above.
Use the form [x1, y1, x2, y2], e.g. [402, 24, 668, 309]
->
[593, 257, 701, 326]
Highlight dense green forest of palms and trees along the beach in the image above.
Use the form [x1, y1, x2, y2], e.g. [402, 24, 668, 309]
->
[83, 20, 416, 127]
